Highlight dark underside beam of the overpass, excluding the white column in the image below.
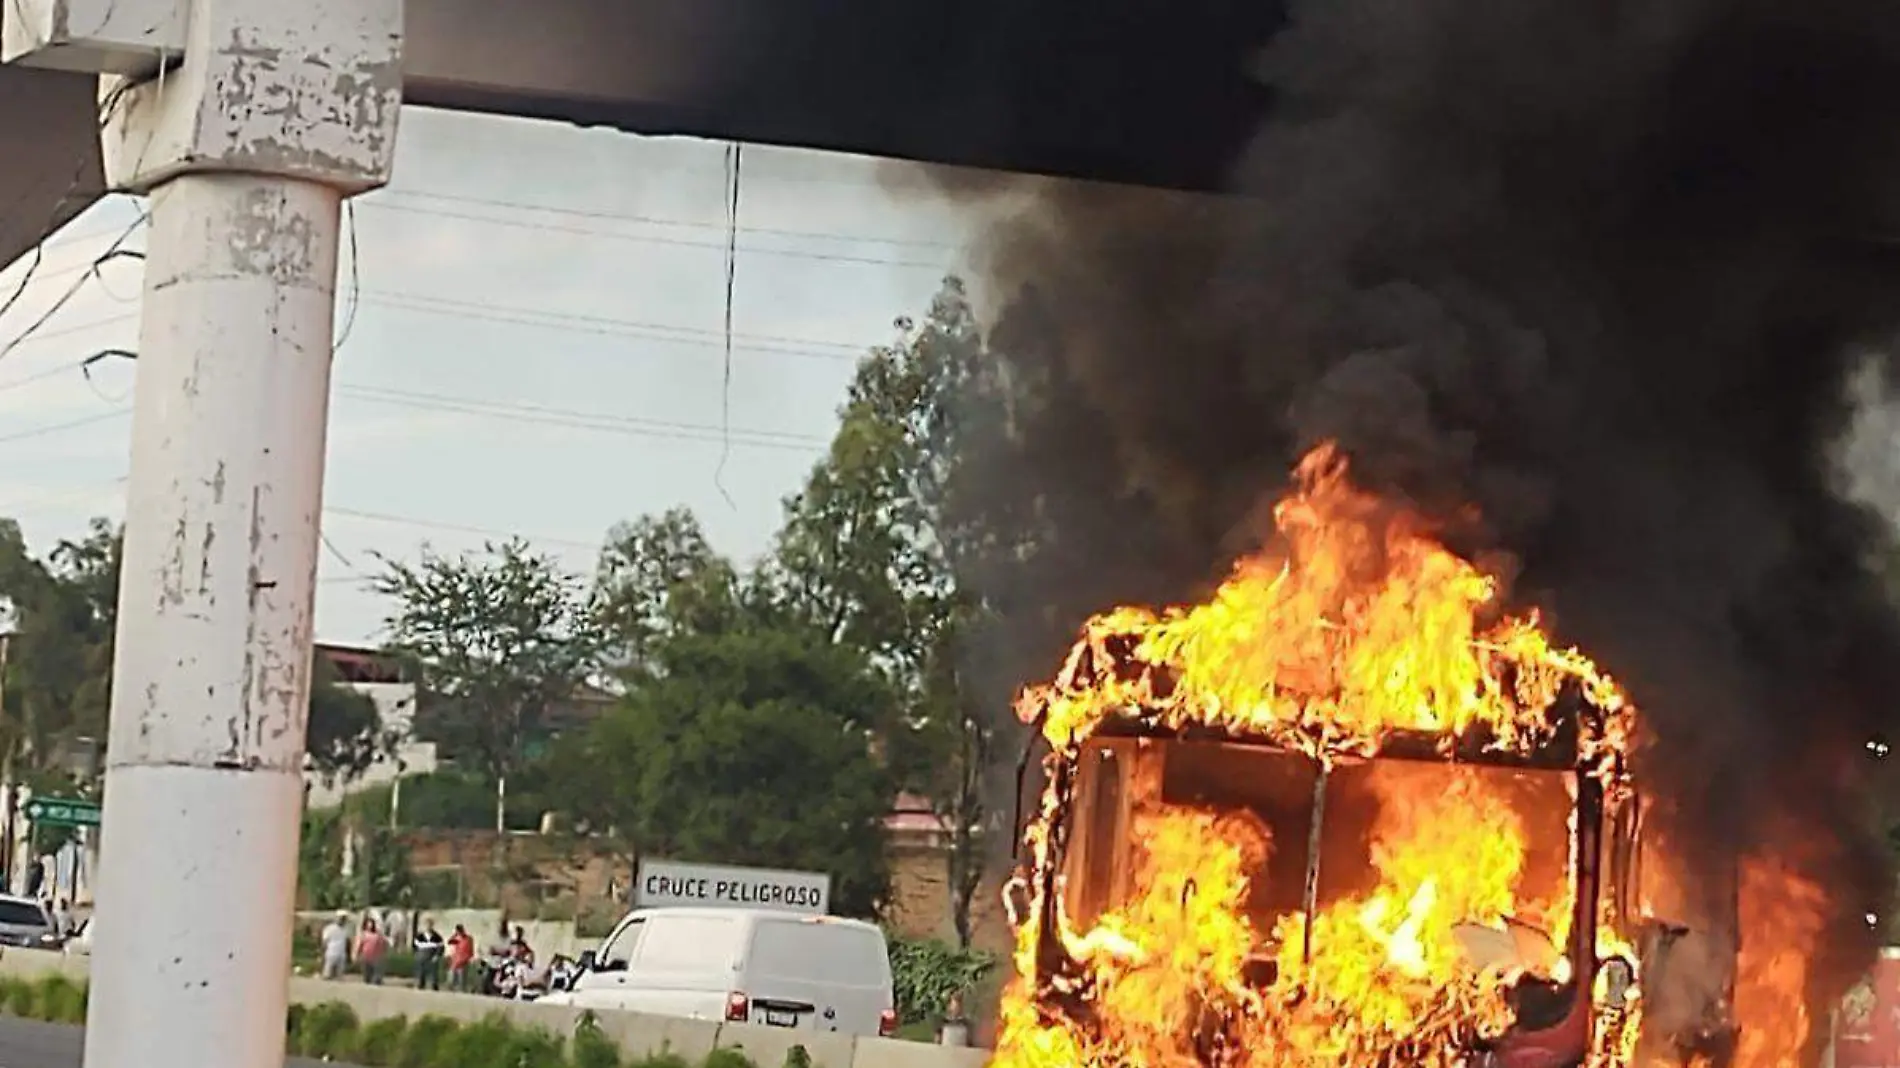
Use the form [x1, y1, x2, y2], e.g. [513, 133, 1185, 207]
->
[0, 0, 1279, 262]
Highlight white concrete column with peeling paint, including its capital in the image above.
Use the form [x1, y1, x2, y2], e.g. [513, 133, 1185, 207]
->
[86, 0, 401, 1068]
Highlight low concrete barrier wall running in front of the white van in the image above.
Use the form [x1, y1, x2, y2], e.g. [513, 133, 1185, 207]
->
[0, 948, 990, 1068]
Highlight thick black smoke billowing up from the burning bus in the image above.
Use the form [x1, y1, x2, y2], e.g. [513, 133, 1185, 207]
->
[950, 0, 1900, 1026]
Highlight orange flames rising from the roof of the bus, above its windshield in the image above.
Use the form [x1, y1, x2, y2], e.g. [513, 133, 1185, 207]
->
[1017, 445, 1628, 754]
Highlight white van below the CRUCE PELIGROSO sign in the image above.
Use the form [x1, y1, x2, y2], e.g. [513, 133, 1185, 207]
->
[543, 908, 897, 1036]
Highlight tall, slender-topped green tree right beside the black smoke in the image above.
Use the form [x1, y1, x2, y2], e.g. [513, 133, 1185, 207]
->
[771, 277, 1011, 944]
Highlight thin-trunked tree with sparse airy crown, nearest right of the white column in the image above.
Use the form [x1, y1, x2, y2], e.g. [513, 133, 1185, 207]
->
[374, 540, 602, 827]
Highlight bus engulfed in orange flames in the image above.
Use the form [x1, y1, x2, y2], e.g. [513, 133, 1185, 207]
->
[994, 447, 1735, 1068]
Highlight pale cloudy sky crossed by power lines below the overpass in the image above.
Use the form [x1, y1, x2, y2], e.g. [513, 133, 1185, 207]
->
[0, 108, 971, 642]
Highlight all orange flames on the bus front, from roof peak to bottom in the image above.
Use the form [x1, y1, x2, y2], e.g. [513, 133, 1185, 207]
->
[992, 445, 1636, 1068]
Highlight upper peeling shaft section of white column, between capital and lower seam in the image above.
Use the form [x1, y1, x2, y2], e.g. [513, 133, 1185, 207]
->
[108, 175, 338, 777]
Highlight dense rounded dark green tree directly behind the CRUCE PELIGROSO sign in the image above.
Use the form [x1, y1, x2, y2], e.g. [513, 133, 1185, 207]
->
[549, 627, 895, 916]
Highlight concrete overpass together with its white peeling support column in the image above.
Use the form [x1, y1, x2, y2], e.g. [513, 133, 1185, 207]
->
[0, 0, 1277, 1068]
